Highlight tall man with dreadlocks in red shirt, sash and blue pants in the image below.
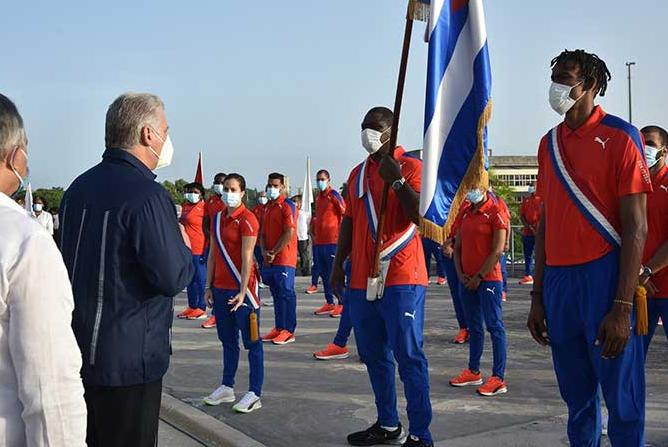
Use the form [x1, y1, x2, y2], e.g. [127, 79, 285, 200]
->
[528, 50, 652, 447]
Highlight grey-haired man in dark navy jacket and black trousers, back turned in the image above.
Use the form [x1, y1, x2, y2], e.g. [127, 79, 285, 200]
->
[60, 93, 194, 447]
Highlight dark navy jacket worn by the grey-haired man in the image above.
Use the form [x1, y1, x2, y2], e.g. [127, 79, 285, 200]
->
[60, 149, 194, 386]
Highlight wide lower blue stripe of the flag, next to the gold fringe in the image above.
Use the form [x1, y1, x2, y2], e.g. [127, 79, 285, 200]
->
[424, 43, 492, 226]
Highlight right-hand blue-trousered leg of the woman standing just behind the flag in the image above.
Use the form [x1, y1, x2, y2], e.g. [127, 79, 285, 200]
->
[480, 281, 507, 380]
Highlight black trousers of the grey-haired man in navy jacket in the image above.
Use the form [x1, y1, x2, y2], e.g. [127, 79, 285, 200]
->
[84, 380, 162, 447]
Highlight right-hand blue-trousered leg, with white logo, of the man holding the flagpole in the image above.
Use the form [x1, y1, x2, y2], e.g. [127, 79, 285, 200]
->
[378, 286, 432, 442]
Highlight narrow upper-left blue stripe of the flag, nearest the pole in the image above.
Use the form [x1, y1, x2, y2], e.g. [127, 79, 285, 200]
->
[424, 0, 469, 132]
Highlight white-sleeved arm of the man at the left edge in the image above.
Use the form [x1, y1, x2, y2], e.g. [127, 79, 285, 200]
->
[9, 234, 86, 447]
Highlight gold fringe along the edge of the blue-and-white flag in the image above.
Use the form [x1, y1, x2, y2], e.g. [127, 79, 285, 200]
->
[420, 99, 492, 244]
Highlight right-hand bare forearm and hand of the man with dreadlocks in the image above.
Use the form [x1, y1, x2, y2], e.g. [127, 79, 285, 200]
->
[597, 193, 647, 358]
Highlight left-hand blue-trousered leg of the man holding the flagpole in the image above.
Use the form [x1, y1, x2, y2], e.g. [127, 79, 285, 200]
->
[347, 290, 399, 427]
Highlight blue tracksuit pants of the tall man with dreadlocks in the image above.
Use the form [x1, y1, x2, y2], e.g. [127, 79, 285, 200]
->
[543, 251, 645, 447]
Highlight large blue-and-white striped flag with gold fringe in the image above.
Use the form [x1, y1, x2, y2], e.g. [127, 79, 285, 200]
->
[420, 0, 492, 242]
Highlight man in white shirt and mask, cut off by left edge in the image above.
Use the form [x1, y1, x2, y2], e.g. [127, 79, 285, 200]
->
[0, 94, 86, 447]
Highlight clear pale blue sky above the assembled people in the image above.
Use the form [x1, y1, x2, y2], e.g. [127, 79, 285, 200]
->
[0, 0, 668, 191]
